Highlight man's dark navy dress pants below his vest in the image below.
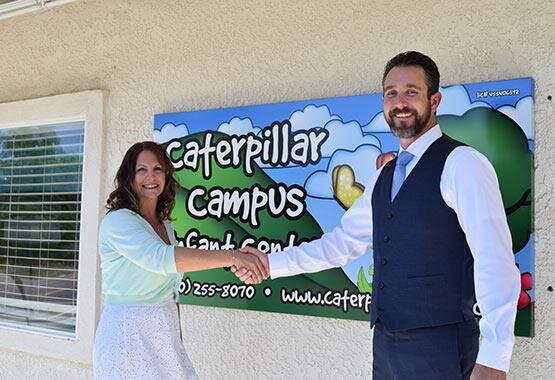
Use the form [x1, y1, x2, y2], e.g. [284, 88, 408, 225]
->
[372, 320, 479, 380]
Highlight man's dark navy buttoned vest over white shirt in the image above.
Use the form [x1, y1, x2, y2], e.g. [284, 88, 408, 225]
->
[371, 135, 474, 331]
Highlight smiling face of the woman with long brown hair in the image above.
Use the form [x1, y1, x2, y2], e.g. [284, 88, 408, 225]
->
[133, 150, 166, 203]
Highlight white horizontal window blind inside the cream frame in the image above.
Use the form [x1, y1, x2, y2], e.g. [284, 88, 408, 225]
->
[0, 122, 84, 336]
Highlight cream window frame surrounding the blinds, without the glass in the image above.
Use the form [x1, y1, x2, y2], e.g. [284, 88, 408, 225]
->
[0, 91, 103, 364]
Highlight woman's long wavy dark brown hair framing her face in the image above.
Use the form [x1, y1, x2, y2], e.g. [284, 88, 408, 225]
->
[106, 141, 177, 221]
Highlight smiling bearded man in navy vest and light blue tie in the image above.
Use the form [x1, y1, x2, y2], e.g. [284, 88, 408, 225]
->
[236, 52, 520, 380]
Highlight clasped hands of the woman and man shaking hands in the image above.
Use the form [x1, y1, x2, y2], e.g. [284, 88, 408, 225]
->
[231, 247, 270, 285]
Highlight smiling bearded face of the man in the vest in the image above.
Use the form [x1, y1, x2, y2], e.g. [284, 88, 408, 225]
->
[383, 66, 441, 139]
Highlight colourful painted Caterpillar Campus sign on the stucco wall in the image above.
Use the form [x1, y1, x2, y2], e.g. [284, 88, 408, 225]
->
[154, 78, 534, 336]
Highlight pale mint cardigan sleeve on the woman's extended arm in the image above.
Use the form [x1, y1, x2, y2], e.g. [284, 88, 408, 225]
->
[99, 209, 177, 274]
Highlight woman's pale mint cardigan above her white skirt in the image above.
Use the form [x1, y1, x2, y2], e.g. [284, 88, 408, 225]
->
[98, 209, 181, 305]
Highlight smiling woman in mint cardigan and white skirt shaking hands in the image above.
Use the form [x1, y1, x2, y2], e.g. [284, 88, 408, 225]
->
[93, 141, 267, 379]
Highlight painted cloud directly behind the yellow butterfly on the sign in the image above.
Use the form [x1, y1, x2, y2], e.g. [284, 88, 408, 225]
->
[304, 145, 382, 199]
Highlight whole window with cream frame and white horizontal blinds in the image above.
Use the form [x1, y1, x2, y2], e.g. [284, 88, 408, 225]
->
[0, 91, 103, 363]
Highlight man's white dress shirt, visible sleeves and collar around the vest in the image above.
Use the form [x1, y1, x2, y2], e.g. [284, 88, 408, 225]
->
[268, 125, 520, 371]
